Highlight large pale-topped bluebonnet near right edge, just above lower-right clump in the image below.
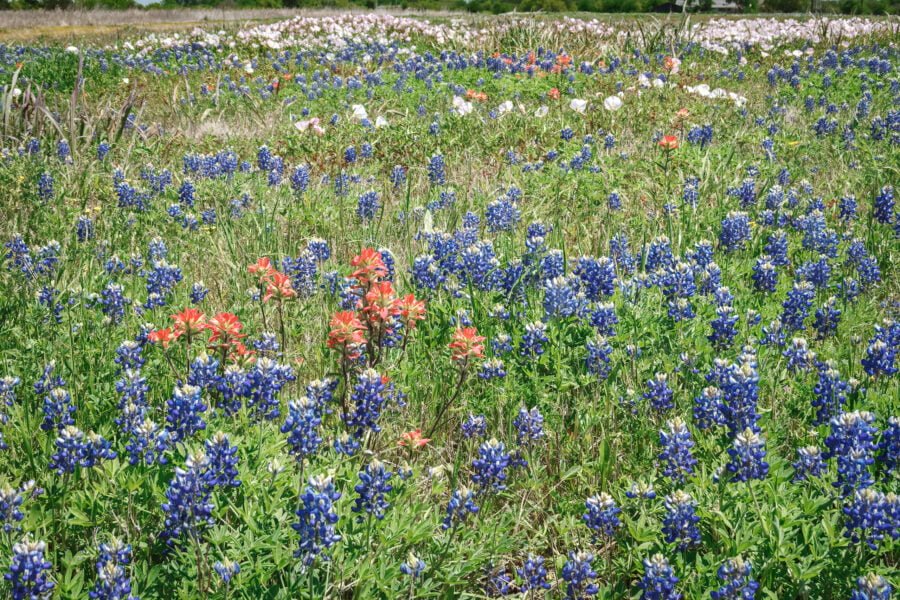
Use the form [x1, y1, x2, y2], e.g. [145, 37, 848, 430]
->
[825, 411, 878, 496]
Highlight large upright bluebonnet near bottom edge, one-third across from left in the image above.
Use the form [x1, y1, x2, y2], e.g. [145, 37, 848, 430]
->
[291, 475, 341, 567]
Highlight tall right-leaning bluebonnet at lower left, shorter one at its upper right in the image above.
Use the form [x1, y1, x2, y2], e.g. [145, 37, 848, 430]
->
[161, 450, 214, 546]
